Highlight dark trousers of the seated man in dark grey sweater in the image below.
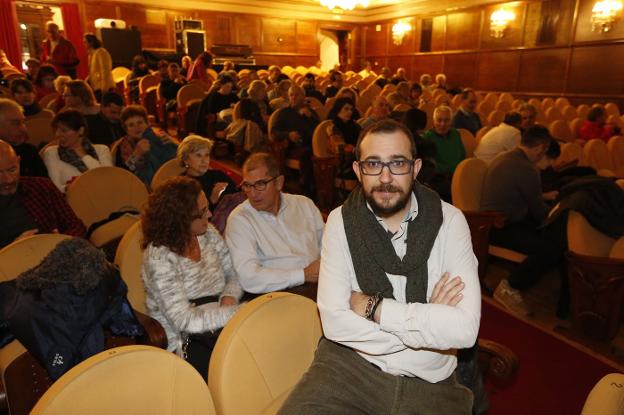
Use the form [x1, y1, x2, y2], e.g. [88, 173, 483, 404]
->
[490, 215, 568, 290]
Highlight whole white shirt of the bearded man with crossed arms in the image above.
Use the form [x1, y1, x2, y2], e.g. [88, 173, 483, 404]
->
[317, 195, 481, 382]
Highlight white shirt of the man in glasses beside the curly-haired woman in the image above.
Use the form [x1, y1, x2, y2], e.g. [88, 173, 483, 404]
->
[225, 193, 324, 294]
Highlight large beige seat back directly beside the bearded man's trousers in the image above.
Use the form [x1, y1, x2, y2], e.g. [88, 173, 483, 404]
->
[208, 292, 322, 415]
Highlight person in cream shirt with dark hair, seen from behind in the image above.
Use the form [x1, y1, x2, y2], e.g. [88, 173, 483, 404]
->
[474, 111, 522, 163]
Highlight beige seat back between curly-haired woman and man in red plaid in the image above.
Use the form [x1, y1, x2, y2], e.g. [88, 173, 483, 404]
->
[67, 167, 147, 227]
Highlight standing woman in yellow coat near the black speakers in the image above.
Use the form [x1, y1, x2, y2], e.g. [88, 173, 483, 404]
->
[84, 33, 115, 101]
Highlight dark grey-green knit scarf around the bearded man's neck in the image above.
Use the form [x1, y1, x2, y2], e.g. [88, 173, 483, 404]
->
[342, 183, 442, 303]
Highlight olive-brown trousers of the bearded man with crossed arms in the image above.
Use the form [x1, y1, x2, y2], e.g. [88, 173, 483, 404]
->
[278, 339, 472, 415]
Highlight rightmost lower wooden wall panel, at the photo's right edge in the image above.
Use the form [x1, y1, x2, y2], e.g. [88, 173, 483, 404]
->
[566, 44, 624, 95]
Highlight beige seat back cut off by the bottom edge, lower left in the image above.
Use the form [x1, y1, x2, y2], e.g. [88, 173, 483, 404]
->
[31, 346, 216, 415]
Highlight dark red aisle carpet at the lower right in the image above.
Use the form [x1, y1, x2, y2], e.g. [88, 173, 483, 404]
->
[479, 300, 619, 415]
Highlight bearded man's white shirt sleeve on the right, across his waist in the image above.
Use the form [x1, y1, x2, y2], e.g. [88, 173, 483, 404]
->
[380, 209, 481, 350]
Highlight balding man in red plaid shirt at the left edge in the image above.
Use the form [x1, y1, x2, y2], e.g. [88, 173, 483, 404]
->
[0, 140, 86, 248]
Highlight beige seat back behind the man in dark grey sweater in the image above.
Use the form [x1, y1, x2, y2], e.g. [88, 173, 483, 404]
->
[451, 158, 487, 212]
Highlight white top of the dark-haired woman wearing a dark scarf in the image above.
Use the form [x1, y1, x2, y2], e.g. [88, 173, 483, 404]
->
[42, 144, 113, 193]
